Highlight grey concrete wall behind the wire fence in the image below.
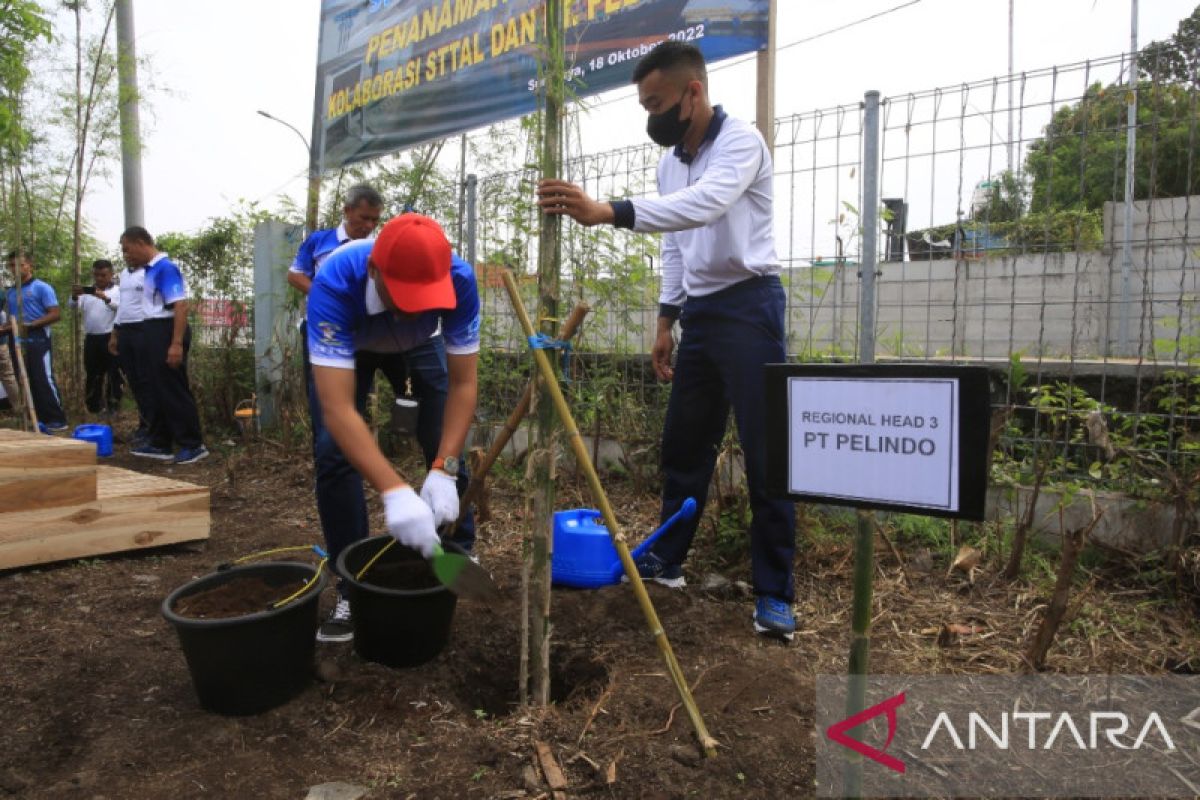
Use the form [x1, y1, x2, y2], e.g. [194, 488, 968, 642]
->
[485, 197, 1200, 362]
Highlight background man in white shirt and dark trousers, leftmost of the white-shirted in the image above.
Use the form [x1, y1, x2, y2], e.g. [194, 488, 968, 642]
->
[71, 258, 121, 414]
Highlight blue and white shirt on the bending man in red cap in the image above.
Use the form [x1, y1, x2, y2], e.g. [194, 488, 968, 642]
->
[308, 239, 480, 369]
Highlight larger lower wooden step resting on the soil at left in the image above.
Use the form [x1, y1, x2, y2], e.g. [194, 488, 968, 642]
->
[0, 467, 209, 569]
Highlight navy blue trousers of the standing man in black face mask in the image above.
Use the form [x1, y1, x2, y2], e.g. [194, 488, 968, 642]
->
[653, 276, 796, 602]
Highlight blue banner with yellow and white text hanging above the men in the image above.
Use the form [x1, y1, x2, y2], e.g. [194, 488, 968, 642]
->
[313, 0, 769, 172]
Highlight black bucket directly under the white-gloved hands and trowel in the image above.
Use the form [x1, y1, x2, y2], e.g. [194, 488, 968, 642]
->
[337, 536, 462, 667]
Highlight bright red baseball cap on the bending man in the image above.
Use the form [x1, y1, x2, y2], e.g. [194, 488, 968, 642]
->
[371, 213, 458, 313]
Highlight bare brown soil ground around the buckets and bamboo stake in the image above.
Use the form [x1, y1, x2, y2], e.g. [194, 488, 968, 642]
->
[0, 429, 1200, 800]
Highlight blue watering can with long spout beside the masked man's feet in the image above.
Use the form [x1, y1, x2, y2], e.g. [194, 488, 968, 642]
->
[550, 498, 696, 589]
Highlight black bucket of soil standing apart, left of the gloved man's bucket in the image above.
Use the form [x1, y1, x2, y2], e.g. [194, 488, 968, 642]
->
[162, 561, 328, 716]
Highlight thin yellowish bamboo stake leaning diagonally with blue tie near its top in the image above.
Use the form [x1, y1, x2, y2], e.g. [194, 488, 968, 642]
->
[502, 270, 716, 758]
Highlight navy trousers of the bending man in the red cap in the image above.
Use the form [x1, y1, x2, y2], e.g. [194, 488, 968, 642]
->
[308, 336, 475, 587]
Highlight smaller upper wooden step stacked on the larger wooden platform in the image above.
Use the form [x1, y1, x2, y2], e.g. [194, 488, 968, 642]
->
[0, 428, 96, 513]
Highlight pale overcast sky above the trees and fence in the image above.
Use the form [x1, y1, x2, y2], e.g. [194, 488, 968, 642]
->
[85, 0, 1196, 245]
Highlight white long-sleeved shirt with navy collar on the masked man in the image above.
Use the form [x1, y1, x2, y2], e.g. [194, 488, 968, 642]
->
[632, 116, 779, 306]
